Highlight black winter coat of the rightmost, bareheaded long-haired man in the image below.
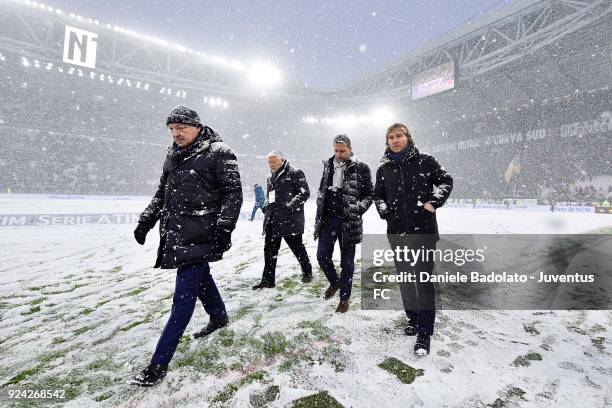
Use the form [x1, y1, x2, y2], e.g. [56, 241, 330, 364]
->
[374, 148, 453, 237]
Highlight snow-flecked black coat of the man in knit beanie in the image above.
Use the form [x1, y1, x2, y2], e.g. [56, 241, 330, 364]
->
[139, 127, 242, 269]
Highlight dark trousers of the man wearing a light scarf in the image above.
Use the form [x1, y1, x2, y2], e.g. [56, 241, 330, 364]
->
[317, 216, 355, 300]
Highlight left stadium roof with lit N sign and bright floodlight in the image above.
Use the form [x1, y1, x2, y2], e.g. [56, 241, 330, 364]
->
[0, 0, 293, 96]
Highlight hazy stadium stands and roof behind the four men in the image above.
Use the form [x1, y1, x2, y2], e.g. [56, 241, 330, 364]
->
[0, 0, 612, 198]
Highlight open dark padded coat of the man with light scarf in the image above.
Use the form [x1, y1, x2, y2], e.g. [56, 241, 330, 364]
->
[314, 156, 374, 245]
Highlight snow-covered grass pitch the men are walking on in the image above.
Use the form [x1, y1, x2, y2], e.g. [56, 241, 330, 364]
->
[0, 199, 612, 408]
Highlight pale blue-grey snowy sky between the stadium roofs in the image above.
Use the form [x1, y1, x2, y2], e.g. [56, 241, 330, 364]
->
[47, 0, 516, 89]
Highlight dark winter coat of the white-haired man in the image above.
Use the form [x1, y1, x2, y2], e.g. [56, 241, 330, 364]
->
[262, 161, 310, 236]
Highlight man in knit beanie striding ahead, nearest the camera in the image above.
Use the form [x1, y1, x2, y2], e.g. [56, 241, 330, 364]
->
[132, 106, 242, 387]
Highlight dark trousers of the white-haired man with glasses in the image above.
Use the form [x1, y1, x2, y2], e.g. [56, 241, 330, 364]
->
[261, 228, 312, 284]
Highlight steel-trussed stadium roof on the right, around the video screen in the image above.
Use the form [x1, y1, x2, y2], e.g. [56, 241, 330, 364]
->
[332, 0, 612, 101]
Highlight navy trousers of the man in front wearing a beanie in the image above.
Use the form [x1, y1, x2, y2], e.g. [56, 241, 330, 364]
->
[151, 263, 227, 364]
